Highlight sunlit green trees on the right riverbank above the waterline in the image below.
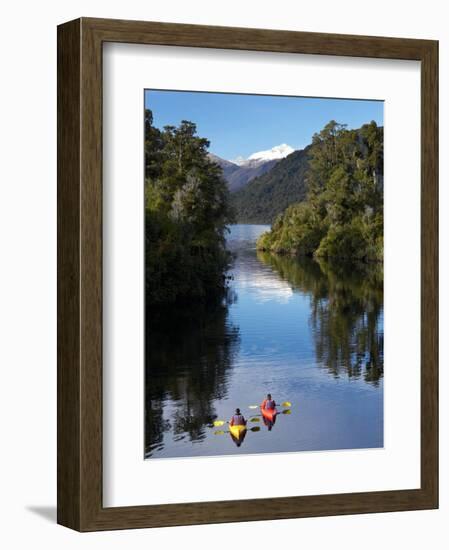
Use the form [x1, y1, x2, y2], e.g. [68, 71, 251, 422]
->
[257, 121, 383, 261]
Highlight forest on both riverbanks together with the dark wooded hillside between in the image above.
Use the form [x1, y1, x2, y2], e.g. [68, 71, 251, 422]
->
[145, 113, 383, 314]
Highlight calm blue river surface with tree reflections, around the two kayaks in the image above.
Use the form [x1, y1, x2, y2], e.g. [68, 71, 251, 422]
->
[145, 225, 383, 458]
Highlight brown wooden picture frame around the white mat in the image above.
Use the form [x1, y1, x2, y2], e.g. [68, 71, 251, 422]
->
[58, 18, 438, 531]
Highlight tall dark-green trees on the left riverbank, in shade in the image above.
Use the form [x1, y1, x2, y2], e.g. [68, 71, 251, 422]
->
[145, 110, 232, 305]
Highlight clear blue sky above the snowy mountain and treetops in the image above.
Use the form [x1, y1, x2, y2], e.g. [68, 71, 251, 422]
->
[145, 90, 383, 160]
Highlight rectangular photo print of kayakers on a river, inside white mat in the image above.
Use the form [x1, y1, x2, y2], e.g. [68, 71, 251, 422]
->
[143, 90, 384, 460]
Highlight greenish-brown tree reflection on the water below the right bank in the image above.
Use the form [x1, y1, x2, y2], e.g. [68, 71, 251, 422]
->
[257, 252, 383, 385]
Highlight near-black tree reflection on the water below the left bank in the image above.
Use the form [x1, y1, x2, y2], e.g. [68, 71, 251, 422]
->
[145, 293, 239, 458]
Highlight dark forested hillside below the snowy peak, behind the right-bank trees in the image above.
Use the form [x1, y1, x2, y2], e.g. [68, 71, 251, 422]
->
[231, 146, 310, 224]
